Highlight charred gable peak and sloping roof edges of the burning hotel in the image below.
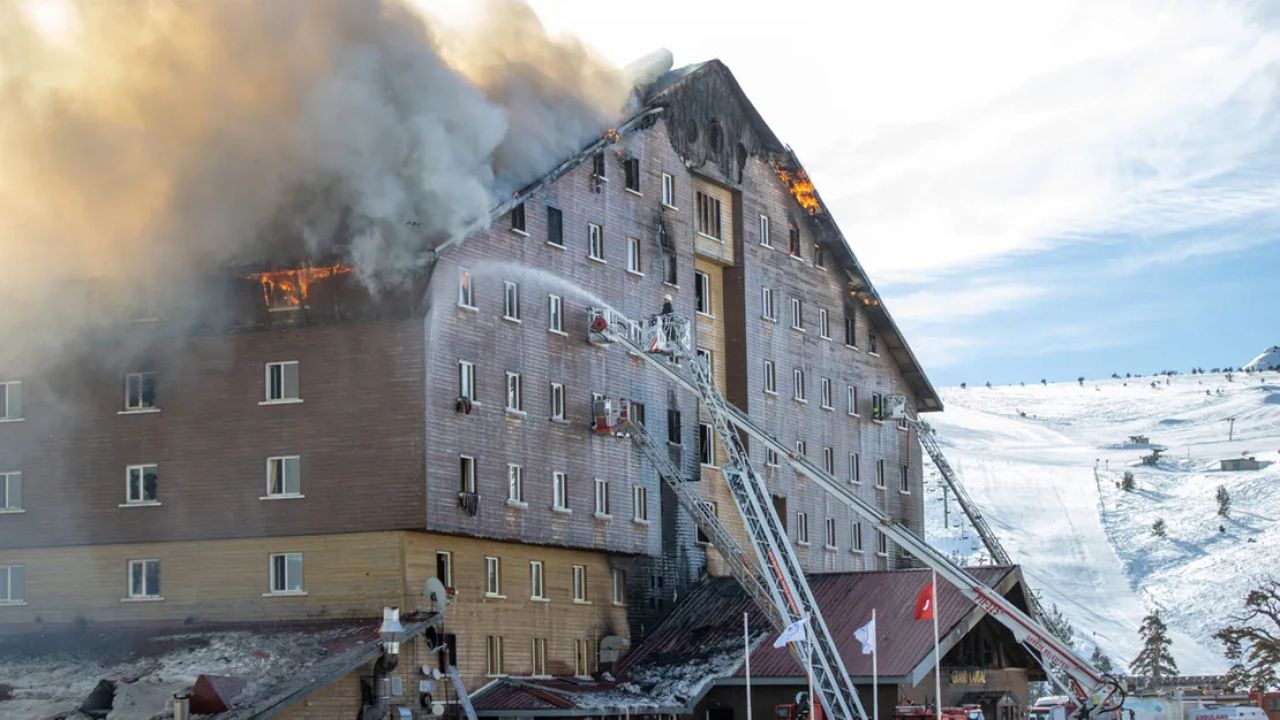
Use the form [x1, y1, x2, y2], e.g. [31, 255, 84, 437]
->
[483, 60, 942, 413]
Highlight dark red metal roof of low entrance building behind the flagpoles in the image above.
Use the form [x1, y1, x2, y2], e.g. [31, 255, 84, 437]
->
[472, 566, 1025, 716]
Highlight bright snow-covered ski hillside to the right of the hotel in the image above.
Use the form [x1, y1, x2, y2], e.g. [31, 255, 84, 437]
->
[925, 373, 1280, 673]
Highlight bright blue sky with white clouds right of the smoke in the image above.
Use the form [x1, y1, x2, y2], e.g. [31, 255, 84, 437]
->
[432, 0, 1280, 386]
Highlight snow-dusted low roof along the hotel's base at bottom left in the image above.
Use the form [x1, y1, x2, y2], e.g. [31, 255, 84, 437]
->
[0, 614, 439, 720]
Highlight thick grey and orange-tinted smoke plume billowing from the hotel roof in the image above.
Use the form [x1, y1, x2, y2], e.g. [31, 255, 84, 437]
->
[0, 0, 630, 315]
